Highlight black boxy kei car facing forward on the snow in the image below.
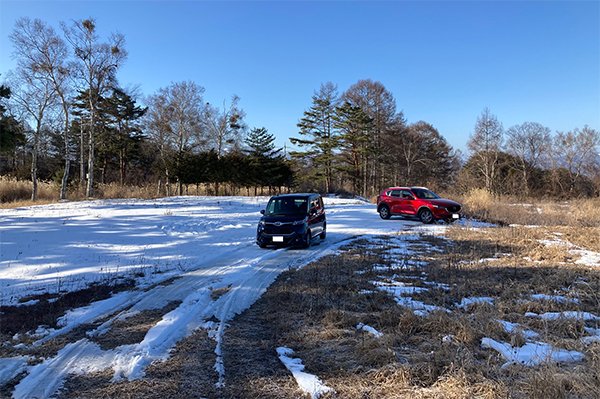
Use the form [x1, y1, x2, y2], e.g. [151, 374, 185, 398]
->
[256, 194, 327, 248]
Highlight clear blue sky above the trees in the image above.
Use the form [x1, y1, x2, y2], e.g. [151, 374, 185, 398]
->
[0, 0, 600, 150]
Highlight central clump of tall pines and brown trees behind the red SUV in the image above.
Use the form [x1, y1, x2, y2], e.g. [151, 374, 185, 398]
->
[290, 80, 460, 195]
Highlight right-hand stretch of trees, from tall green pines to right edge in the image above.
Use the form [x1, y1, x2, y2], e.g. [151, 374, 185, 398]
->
[290, 80, 600, 198]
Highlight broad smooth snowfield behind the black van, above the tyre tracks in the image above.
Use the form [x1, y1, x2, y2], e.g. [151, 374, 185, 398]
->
[0, 197, 420, 305]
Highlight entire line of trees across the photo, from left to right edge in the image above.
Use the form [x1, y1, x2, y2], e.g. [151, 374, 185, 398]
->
[0, 18, 600, 200]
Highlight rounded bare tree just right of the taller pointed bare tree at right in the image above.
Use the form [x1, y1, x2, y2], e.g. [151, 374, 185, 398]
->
[506, 122, 552, 195]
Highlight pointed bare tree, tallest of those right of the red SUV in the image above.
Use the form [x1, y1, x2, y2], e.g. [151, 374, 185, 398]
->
[467, 108, 504, 192]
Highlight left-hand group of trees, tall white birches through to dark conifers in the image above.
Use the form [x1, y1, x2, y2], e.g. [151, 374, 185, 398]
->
[0, 18, 294, 200]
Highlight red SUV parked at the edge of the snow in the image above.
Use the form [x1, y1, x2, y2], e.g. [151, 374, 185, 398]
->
[377, 187, 461, 223]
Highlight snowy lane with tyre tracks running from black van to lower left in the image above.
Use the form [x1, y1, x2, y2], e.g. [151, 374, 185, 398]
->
[13, 238, 352, 399]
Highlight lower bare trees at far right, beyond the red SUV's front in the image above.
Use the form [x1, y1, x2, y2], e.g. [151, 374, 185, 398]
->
[459, 108, 600, 198]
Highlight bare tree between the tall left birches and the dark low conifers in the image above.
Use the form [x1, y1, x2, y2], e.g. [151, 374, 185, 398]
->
[146, 81, 207, 195]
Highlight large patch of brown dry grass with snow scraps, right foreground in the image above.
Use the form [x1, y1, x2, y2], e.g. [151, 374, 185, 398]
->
[213, 227, 600, 398]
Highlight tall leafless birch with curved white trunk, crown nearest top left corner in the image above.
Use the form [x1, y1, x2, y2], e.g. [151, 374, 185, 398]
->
[10, 18, 71, 199]
